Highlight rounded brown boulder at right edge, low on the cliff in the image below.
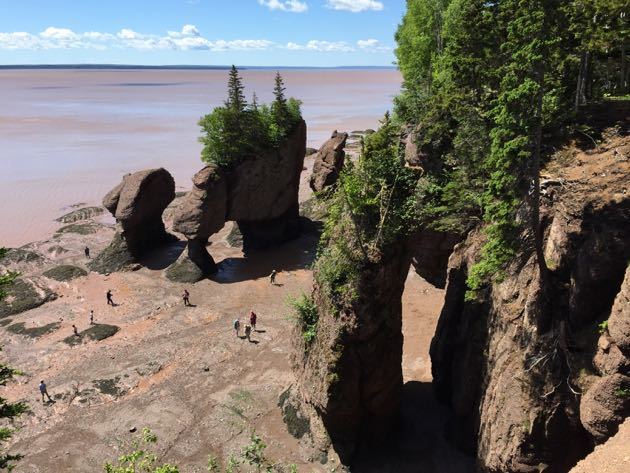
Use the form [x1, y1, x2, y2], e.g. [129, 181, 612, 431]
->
[580, 373, 630, 443]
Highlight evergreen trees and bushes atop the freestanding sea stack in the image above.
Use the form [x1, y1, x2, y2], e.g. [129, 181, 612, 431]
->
[199, 66, 302, 168]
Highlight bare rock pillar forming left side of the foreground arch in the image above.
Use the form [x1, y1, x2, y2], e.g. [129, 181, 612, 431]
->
[283, 245, 410, 462]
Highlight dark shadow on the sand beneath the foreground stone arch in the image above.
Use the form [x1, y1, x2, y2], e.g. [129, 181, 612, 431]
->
[351, 381, 474, 473]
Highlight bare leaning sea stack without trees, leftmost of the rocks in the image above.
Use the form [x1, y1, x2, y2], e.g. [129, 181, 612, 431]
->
[88, 168, 175, 273]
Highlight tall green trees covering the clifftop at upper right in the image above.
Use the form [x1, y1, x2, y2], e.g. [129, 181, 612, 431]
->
[395, 0, 630, 295]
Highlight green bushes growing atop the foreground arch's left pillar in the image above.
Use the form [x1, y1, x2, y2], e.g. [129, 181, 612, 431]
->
[314, 114, 418, 305]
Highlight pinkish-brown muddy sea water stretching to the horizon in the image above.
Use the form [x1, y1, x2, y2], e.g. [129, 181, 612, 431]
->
[0, 69, 401, 247]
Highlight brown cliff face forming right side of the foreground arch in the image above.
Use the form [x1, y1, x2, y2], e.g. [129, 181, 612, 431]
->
[431, 139, 630, 472]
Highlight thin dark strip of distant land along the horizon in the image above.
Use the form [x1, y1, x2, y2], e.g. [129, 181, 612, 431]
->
[0, 64, 396, 71]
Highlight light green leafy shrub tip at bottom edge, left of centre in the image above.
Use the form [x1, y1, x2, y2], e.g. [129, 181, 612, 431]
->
[103, 427, 179, 473]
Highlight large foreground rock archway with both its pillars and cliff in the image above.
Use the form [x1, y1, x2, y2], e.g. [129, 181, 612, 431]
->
[288, 136, 630, 473]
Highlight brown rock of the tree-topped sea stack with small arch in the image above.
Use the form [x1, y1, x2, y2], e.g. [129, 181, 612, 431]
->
[166, 121, 306, 282]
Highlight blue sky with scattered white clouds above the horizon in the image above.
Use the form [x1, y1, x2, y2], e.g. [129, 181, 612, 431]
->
[0, 0, 405, 66]
